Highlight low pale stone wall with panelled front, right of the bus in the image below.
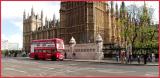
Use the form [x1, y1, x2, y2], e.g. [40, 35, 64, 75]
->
[65, 43, 97, 60]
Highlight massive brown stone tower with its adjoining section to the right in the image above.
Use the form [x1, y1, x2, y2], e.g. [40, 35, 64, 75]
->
[60, 1, 127, 44]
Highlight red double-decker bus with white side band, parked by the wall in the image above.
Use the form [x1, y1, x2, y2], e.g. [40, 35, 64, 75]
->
[29, 38, 64, 61]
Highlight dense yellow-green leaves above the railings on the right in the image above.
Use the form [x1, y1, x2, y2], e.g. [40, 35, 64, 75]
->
[117, 3, 158, 54]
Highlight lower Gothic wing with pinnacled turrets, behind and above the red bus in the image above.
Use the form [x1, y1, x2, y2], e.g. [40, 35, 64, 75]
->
[23, 8, 59, 52]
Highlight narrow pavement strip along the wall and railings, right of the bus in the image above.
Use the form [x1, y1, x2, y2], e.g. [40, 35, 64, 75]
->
[64, 59, 159, 66]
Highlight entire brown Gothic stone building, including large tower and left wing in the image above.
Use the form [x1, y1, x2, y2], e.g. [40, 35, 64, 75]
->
[23, 1, 135, 51]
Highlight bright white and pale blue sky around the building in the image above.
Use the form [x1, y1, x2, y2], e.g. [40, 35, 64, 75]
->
[1, 1, 159, 48]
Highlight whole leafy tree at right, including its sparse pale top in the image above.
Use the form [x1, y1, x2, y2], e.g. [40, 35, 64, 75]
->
[117, 4, 158, 54]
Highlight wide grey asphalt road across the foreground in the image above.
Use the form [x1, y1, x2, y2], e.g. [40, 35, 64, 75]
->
[2, 57, 158, 77]
